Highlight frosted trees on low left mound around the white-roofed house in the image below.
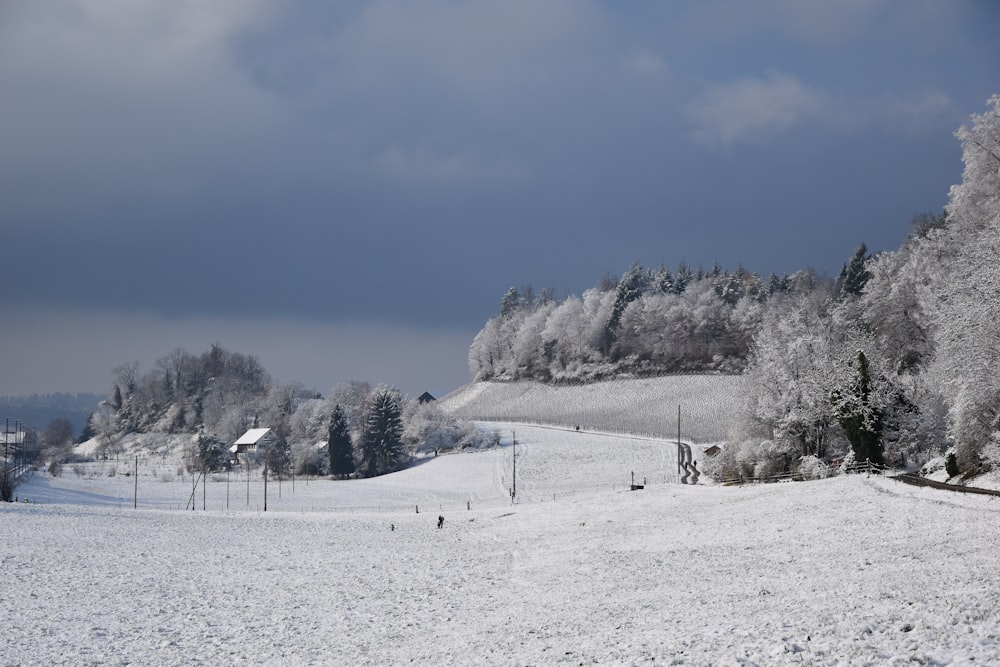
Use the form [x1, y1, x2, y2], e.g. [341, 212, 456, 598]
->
[26, 344, 495, 486]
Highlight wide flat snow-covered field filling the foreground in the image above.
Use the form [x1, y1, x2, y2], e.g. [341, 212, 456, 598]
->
[0, 426, 1000, 665]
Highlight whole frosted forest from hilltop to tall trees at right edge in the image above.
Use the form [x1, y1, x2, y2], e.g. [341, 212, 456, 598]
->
[469, 96, 1000, 476]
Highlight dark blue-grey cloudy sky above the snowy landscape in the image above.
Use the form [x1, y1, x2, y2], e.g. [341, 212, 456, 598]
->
[0, 0, 1000, 402]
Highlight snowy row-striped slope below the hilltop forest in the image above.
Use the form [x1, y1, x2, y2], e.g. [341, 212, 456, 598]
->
[438, 375, 746, 442]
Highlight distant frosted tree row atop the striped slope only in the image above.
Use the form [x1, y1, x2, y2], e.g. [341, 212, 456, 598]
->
[469, 262, 804, 382]
